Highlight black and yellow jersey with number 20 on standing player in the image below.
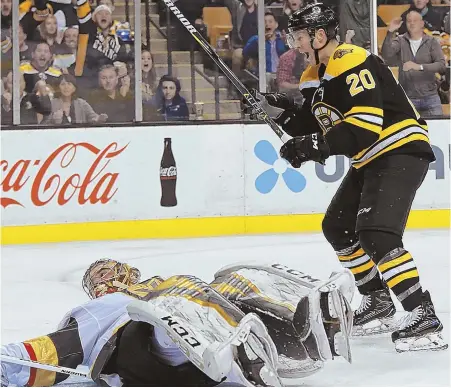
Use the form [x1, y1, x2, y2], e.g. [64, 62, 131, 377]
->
[299, 44, 434, 169]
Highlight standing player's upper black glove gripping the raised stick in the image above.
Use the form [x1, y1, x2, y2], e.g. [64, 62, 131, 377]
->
[242, 89, 296, 119]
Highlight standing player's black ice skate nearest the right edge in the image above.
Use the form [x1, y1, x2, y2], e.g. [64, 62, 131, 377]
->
[392, 291, 448, 353]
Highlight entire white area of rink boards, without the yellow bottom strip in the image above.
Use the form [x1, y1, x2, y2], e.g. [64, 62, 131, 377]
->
[1, 120, 450, 226]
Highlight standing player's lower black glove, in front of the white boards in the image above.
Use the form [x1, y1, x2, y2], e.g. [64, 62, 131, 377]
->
[280, 133, 330, 168]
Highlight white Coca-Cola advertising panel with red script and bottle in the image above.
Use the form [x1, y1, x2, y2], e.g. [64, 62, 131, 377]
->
[1, 126, 244, 226]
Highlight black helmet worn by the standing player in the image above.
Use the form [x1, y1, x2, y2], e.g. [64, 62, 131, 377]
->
[287, 3, 338, 50]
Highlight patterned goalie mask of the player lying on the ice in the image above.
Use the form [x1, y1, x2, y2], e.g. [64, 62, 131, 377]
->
[82, 259, 141, 299]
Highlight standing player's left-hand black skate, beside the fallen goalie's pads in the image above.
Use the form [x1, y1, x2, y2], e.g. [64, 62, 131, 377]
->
[352, 287, 399, 337]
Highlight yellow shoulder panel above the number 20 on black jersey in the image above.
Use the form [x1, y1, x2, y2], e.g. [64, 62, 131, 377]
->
[324, 44, 371, 79]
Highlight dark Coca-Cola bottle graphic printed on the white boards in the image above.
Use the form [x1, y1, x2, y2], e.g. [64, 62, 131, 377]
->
[160, 137, 177, 207]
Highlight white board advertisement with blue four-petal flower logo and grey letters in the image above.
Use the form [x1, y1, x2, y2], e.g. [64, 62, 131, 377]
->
[244, 120, 450, 215]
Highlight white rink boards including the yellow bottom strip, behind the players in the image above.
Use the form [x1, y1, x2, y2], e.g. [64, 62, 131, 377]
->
[1, 120, 450, 244]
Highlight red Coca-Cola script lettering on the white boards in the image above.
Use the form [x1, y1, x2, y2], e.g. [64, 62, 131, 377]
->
[0, 142, 127, 208]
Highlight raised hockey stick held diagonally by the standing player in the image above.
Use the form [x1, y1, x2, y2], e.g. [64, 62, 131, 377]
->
[163, 0, 291, 143]
